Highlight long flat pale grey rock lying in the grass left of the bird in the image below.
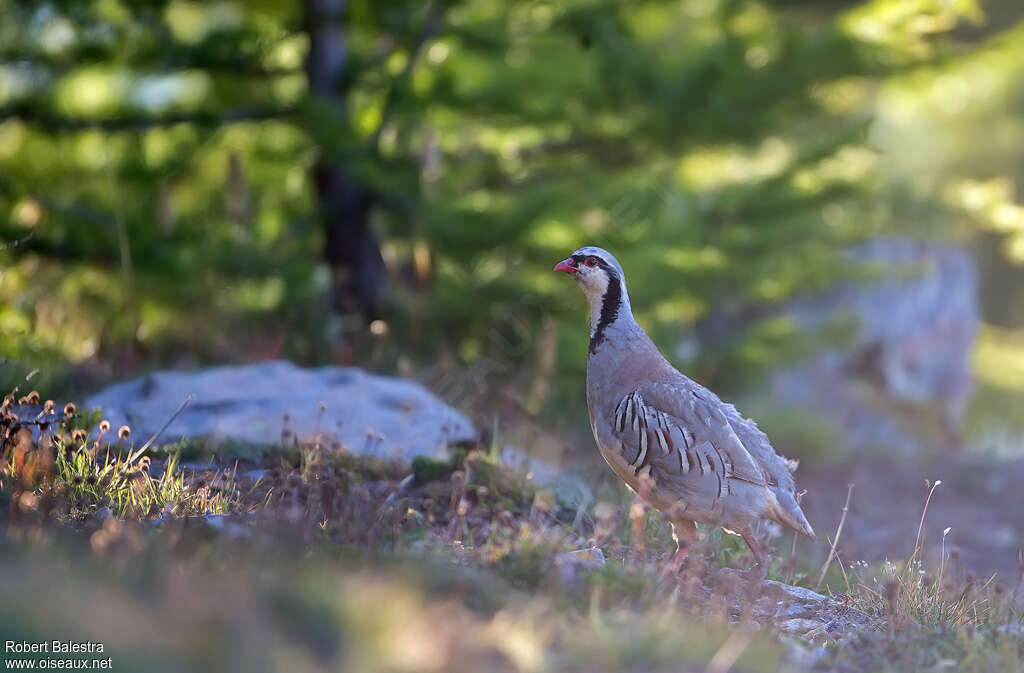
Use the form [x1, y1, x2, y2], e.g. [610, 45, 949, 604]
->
[85, 361, 477, 460]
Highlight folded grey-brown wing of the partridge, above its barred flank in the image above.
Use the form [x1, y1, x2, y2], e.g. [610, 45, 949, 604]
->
[611, 383, 769, 516]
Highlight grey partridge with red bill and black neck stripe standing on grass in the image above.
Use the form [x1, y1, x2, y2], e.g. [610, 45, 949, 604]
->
[554, 246, 814, 581]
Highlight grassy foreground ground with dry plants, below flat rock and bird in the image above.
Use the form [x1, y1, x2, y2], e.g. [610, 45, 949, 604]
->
[0, 385, 1024, 673]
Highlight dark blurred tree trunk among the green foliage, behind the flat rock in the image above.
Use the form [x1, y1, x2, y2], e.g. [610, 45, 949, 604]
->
[303, 0, 387, 322]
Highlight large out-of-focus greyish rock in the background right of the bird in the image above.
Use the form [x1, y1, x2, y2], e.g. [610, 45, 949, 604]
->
[770, 239, 980, 453]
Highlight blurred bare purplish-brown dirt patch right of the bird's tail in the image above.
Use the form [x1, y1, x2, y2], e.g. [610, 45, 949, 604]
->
[798, 456, 1024, 585]
